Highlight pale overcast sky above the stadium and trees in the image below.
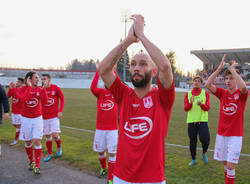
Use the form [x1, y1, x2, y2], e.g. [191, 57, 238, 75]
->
[0, 0, 250, 72]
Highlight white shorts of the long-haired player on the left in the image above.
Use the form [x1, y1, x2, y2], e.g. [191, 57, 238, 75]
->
[20, 116, 43, 141]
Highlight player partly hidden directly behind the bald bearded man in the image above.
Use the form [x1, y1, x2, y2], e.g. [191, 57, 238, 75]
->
[90, 64, 118, 184]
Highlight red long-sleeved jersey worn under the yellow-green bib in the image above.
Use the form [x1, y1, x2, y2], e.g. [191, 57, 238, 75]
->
[184, 88, 210, 112]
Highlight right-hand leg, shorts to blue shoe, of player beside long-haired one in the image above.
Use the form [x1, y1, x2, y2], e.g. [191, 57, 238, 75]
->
[50, 118, 62, 157]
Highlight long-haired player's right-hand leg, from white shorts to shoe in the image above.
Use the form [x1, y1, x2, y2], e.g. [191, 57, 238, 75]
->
[32, 116, 43, 174]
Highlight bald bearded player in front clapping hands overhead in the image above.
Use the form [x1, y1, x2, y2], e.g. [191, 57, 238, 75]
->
[99, 15, 175, 184]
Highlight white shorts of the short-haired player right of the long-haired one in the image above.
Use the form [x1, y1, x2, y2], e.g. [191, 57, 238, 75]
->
[43, 117, 61, 135]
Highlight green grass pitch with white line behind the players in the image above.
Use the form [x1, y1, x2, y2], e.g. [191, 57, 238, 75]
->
[0, 89, 250, 184]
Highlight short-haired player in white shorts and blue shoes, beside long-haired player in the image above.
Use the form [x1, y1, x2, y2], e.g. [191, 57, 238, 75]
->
[42, 74, 65, 162]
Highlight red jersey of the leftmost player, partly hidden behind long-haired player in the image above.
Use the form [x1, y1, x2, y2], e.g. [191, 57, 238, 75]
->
[7, 88, 23, 114]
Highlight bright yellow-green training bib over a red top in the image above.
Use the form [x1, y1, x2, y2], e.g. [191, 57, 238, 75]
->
[187, 89, 208, 123]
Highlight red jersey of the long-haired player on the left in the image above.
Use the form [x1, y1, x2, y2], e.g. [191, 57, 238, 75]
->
[14, 86, 48, 118]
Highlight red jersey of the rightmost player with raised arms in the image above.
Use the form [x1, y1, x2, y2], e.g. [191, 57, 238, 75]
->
[214, 87, 248, 136]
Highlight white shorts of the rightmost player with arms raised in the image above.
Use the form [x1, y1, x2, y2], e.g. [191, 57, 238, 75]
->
[214, 134, 243, 164]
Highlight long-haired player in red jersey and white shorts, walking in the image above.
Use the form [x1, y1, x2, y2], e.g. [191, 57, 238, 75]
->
[12, 71, 48, 174]
